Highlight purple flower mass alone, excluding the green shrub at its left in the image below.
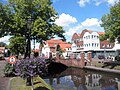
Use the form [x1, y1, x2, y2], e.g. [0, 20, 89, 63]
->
[15, 58, 47, 78]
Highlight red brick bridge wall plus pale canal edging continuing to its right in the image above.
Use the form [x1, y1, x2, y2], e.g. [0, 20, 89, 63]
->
[56, 52, 120, 74]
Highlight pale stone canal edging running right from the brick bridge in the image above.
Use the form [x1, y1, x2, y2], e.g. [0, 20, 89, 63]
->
[84, 66, 120, 74]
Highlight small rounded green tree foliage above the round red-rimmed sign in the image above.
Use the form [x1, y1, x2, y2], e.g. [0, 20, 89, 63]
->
[8, 36, 26, 55]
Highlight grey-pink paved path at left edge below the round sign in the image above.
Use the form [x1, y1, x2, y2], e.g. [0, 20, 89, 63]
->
[0, 60, 10, 90]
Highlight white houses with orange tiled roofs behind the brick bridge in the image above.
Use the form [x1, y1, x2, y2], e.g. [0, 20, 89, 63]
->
[42, 39, 71, 58]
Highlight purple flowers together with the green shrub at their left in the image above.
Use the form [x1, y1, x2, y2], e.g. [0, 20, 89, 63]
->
[4, 58, 47, 78]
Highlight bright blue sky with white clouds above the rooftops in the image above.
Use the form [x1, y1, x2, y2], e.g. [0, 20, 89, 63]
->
[0, 0, 119, 47]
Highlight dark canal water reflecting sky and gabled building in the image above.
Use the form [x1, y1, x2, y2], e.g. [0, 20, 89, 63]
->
[45, 68, 120, 90]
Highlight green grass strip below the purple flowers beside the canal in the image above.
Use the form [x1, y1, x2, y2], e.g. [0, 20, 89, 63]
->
[10, 77, 54, 90]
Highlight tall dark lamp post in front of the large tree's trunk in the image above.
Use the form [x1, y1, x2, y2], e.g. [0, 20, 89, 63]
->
[25, 17, 33, 58]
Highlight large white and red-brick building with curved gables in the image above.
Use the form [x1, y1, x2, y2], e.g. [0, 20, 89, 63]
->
[71, 29, 120, 57]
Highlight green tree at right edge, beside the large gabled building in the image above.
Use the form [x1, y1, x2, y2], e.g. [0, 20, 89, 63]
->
[101, 1, 120, 43]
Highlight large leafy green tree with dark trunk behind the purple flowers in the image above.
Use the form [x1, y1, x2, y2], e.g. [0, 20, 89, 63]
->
[0, 0, 65, 57]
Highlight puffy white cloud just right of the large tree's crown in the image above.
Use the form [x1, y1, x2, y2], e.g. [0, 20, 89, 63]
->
[55, 13, 77, 26]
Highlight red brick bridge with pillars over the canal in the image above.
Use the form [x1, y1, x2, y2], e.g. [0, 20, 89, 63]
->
[56, 52, 92, 68]
